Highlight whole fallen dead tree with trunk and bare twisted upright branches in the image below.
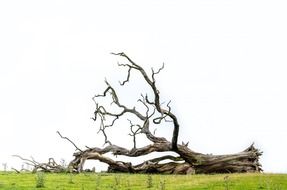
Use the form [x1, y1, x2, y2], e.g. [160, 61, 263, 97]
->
[63, 53, 262, 174]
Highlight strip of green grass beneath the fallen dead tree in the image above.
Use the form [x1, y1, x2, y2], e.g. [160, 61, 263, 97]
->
[0, 172, 287, 190]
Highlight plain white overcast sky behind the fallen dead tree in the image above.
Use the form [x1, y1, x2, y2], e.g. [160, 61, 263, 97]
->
[0, 0, 287, 172]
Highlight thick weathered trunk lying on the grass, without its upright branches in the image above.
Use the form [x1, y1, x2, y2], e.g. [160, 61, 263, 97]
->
[66, 143, 262, 174]
